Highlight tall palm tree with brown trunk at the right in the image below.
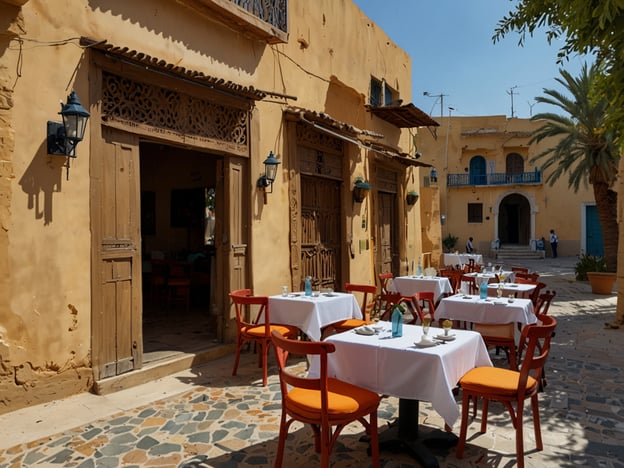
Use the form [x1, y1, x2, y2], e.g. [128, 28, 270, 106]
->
[531, 64, 620, 272]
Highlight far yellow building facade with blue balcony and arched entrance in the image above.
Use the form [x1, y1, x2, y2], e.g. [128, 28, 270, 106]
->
[418, 115, 602, 258]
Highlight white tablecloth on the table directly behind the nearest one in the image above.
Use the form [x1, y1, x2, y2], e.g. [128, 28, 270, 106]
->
[436, 294, 537, 325]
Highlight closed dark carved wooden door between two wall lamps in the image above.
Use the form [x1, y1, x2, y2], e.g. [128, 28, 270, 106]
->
[299, 175, 342, 290]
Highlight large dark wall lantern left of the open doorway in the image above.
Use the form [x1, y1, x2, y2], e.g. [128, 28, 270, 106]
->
[48, 91, 91, 179]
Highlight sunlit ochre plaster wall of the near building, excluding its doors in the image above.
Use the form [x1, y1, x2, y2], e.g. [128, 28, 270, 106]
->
[0, 0, 439, 412]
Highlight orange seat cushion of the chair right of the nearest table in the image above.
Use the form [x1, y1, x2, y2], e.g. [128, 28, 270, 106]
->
[459, 367, 537, 396]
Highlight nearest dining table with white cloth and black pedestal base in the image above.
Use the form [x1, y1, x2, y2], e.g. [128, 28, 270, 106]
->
[309, 321, 492, 467]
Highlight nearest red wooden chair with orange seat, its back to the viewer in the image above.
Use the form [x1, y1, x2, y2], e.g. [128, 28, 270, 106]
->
[272, 331, 381, 468]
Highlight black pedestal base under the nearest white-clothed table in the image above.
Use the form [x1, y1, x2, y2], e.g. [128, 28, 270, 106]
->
[379, 398, 457, 468]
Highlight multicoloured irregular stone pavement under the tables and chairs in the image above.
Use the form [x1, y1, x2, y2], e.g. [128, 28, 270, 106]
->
[0, 258, 624, 468]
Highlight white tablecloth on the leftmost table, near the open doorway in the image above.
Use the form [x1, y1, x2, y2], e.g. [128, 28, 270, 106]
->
[269, 292, 362, 341]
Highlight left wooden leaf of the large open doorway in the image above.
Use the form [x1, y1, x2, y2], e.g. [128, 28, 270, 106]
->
[91, 127, 143, 380]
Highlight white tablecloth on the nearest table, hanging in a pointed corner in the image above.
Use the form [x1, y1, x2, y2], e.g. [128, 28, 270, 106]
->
[310, 322, 492, 426]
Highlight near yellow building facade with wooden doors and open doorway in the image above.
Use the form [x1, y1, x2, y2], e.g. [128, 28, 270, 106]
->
[0, 0, 441, 412]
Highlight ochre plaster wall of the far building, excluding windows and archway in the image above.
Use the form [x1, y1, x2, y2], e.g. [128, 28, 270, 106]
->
[419, 116, 594, 256]
